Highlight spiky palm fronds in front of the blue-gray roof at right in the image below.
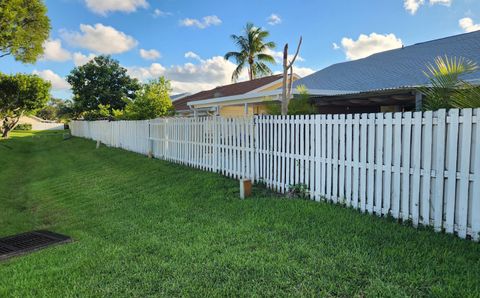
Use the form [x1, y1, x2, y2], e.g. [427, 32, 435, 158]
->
[418, 56, 480, 110]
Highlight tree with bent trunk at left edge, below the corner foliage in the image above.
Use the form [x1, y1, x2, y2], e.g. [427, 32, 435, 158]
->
[0, 73, 51, 138]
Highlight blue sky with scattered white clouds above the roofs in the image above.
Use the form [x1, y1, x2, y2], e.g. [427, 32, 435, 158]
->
[0, 0, 480, 99]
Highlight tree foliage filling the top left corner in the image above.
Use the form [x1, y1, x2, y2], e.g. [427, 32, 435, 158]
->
[0, 0, 50, 63]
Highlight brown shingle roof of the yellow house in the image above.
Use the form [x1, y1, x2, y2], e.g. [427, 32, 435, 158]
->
[173, 74, 282, 111]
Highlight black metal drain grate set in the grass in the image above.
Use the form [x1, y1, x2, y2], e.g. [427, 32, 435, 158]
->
[0, 231, 72, 260]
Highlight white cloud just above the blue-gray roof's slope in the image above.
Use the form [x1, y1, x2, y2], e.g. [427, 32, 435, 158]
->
[342, 33, 402, 60]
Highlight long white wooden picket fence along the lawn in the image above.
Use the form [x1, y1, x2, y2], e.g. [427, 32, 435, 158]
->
[71, 109, 480, 241]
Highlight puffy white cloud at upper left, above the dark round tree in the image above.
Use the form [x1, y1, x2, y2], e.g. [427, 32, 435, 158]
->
[60, 24, 138, 54]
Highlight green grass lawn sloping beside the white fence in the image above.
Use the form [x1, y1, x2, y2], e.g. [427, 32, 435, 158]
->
[0, 133, 480, 297]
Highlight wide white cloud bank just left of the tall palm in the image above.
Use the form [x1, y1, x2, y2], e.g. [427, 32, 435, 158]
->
[127, 52, 247, 93]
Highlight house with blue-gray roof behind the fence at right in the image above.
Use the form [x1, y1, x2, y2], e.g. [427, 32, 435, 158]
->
[294, 31, 480, 113]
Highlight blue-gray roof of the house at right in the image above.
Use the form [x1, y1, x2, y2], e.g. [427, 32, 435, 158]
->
[294, 31, 480, 92]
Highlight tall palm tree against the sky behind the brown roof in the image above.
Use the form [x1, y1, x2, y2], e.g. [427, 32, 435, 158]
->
[225, 23, 275, 81]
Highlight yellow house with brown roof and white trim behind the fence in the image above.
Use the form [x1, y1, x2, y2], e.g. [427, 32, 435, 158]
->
[173, 74, 300, 117]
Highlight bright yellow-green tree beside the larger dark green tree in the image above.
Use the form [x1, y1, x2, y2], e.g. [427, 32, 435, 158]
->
[123, 77, 173, 120]
